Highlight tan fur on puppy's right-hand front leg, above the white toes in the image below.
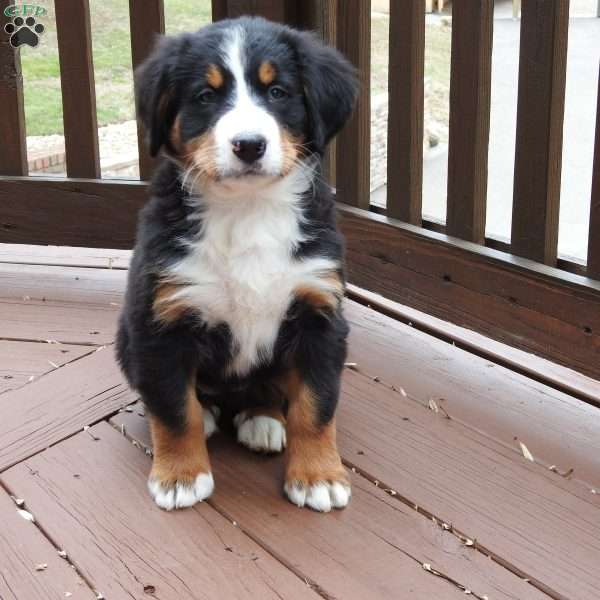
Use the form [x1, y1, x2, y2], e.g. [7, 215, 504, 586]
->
[285, 370, 349, 486]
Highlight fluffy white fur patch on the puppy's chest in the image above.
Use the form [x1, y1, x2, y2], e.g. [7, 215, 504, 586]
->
[169, 171, 337, 375]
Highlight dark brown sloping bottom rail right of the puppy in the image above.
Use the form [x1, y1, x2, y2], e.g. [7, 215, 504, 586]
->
[340, 206, 600, 378]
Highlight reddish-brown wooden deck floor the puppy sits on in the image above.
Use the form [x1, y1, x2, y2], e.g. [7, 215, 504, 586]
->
[0, 245, 600, 600]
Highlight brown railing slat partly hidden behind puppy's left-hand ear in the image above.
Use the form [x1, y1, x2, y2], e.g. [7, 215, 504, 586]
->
[129, 0, 165, 179]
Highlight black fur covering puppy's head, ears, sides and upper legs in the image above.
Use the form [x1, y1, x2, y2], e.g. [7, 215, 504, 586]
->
[117, 18, 356, 429]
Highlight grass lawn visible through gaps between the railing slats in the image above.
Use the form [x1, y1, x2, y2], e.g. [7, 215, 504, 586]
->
[21, 0, 450, 135]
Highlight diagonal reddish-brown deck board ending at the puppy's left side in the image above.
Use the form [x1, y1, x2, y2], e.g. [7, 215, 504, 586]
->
[0, 347, 136, 471]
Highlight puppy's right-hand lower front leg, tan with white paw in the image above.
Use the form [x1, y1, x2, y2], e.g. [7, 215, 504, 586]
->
[284, 370, 350, 512]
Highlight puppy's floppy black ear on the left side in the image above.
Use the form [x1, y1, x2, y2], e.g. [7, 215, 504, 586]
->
[135, 37, 181, 156]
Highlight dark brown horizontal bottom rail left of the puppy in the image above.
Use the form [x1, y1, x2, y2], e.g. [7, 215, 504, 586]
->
[0, 177, 147, 248]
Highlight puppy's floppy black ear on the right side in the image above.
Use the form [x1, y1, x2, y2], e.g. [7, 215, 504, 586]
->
[297, 32, 358, 152]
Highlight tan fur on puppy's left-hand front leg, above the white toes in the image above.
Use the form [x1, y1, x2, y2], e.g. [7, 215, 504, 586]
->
[149, 383, 210, 487]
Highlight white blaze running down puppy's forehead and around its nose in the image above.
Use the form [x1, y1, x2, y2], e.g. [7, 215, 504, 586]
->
[215, 28, 283, 175]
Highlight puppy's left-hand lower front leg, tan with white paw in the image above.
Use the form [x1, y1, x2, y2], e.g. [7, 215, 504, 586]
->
[147, 381, 214, 510]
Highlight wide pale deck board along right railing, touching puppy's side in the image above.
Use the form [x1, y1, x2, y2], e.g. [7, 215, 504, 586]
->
[346, 301, 600, 485]
